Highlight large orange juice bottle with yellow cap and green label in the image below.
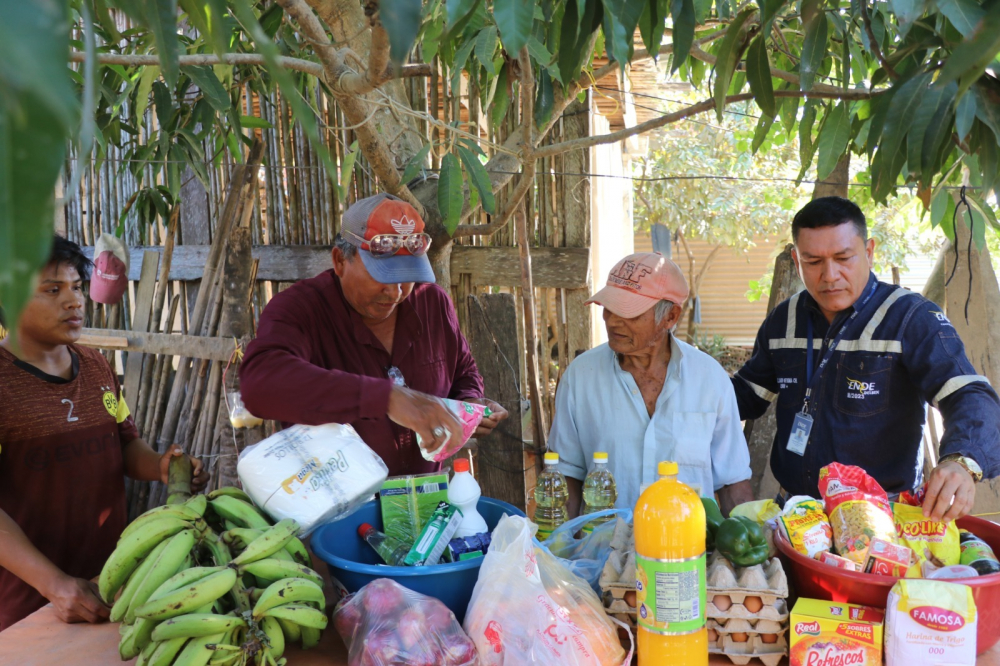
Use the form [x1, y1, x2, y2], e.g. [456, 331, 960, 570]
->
[635, 462, 708, 666]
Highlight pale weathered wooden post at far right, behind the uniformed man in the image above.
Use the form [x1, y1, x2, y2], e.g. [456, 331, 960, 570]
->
[944, 204, 1000, 520]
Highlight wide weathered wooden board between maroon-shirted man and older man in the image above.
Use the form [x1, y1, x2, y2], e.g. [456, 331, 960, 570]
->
[467, 294, 535, 509]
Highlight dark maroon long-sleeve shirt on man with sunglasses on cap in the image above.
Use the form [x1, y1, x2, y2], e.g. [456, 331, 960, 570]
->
[240, 270, 483, 475]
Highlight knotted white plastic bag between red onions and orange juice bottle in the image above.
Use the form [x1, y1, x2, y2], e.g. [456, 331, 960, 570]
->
[465, 516, 632, 666]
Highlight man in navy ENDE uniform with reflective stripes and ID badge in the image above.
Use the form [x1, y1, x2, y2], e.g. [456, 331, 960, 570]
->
[733, 197, 1000, 520]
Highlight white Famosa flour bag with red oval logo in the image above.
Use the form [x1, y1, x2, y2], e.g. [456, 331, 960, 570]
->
[885, 579, 977, 666]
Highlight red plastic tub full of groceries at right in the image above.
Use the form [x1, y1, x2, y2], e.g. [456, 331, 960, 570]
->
[774, 516, 1000, 654]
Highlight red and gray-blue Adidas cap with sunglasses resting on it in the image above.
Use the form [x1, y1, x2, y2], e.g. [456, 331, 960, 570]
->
[342, 192, 436, 284]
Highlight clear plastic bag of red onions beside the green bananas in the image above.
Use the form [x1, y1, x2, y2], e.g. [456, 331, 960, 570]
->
[333, 578, 476, 666]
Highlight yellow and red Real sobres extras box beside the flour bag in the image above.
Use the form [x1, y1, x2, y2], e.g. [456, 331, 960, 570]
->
[788, 599, 885, 666]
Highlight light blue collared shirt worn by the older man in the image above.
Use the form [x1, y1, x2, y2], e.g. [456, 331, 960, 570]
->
[548, 335, 750, 509]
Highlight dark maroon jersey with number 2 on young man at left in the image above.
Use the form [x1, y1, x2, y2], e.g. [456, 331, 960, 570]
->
[0, 345, 139, 631]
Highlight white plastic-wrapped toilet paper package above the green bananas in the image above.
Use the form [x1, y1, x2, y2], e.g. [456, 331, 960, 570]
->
[236, 423, 389, 536]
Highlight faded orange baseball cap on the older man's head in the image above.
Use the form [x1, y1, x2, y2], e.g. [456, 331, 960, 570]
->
[587, 252, 689, 319]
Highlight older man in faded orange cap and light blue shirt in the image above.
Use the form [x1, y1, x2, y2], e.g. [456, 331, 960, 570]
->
[549, 252, 753, 516]
